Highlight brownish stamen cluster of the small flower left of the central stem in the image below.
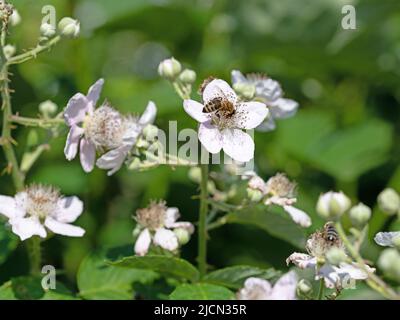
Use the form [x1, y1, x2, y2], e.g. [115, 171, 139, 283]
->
[136, 201, 167, 230]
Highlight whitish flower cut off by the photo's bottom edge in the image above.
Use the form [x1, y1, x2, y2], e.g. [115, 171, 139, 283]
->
[237, 271, 297, 300]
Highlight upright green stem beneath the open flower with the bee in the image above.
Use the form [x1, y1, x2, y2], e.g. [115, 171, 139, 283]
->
[198, 164, 208, 278]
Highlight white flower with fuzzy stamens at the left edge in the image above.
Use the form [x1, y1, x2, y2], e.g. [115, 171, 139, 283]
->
[0, 185, 85, 241]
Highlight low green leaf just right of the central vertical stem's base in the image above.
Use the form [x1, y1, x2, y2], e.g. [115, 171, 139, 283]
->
[203, 266, 280, 290]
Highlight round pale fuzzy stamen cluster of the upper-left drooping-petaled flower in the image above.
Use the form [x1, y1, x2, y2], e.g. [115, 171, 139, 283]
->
[83, 105, 124, 149]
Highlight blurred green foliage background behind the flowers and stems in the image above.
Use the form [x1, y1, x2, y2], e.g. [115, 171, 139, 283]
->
[0, 0, 400, 297]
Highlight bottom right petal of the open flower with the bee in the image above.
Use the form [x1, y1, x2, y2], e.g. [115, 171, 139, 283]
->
[222, 129, 255, 162]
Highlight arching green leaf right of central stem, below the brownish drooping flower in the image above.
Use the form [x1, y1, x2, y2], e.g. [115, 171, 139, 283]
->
[226, 205, 306, 248]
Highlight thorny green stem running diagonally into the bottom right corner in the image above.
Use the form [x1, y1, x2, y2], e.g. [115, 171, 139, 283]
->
[335, 222, 400, 300]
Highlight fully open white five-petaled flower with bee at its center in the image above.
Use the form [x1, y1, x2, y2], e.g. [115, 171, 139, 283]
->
[183, 79, 268, 162]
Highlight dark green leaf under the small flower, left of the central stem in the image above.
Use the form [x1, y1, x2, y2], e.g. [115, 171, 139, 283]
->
[112, 255, 199, 281]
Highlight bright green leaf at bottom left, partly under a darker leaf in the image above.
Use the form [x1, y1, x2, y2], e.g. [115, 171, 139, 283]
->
[77, 252, 157, 300]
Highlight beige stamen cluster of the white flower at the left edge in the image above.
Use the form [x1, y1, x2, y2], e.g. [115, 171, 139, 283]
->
[25, 185, 60, 221]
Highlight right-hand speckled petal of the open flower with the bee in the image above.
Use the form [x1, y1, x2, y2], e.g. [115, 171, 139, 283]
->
[233, 102, 269, 130]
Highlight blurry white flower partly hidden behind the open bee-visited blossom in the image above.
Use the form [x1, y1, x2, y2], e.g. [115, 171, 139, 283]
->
[232, 70, 299, 131]
